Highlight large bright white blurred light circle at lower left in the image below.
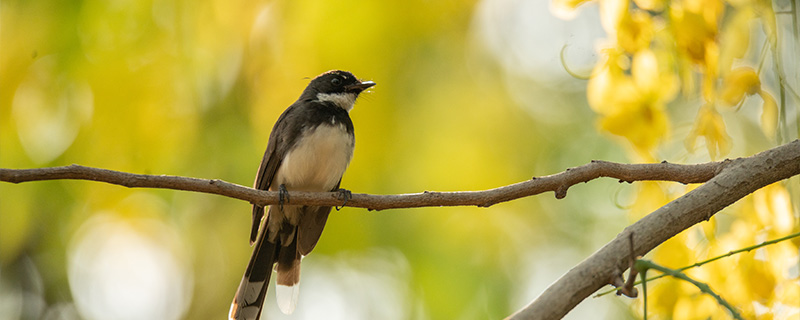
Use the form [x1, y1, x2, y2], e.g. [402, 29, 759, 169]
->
[68, 214, 192, 319]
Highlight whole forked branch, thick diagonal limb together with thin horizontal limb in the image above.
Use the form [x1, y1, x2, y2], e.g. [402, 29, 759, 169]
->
[0, 140, 800, 319]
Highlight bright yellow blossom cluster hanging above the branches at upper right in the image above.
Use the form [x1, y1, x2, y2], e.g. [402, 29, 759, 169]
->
[555, 0, 778, 160]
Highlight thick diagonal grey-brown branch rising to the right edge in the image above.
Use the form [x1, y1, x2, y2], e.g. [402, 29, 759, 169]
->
[508, 140, 800, 320]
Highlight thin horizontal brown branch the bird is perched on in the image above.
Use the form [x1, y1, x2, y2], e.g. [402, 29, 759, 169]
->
[0, 161, 726, 210]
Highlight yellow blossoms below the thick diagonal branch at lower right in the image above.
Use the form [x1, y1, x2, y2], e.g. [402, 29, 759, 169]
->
[636, 183, 800, 320]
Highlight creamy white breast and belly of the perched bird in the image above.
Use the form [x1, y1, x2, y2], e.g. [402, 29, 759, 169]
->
[276, 123, 354, 191]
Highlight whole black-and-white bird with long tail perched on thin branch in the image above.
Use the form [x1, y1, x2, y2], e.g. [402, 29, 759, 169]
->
[228, 70, 375, 320]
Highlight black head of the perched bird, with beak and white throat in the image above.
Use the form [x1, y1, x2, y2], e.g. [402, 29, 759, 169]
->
[303, 70, 375, 111]
